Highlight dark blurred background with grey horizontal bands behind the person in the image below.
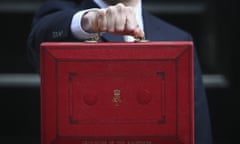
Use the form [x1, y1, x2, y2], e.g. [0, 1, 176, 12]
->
[0, 0, 236, 144]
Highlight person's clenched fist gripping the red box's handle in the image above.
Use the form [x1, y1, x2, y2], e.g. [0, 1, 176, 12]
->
[81, 3, 144, 37]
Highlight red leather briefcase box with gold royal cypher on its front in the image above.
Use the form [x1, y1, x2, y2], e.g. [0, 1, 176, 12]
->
[40, 42, 194, 144]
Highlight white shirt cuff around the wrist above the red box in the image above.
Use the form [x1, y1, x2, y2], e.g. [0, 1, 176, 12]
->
[71, 8, 99, 40]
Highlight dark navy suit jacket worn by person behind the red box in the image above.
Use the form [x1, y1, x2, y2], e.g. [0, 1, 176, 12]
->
[28, 0, 212, 144]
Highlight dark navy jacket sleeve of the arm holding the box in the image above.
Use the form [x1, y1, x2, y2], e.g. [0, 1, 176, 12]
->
[27, 0, 79, 73]
